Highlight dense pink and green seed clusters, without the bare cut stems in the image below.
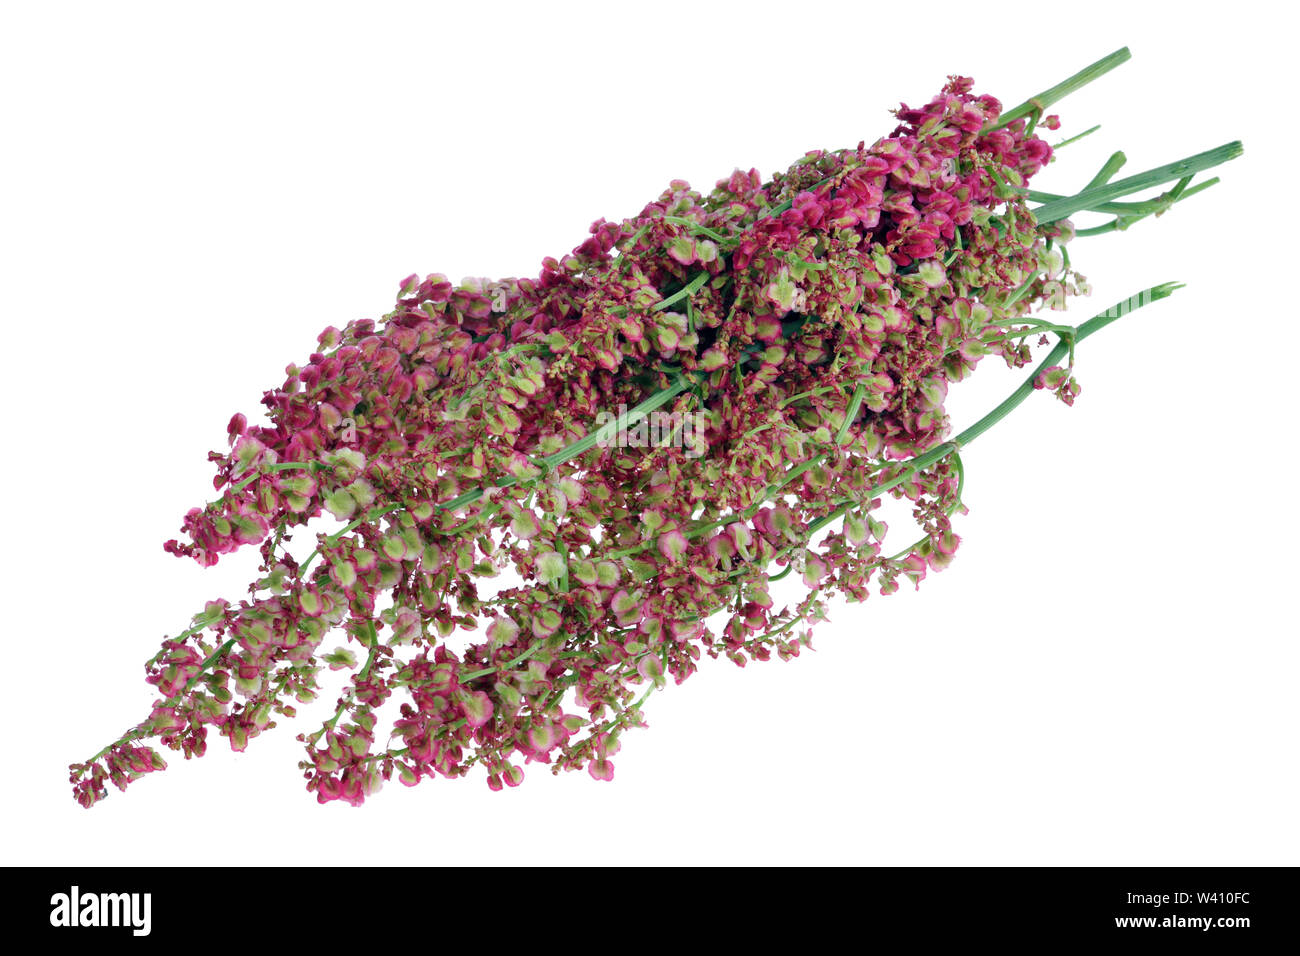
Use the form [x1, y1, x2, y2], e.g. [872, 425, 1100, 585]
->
[73, 78, 1080, 805]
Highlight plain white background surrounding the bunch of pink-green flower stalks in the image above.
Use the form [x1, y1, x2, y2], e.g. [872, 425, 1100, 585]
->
[0, 3, 1300, 865]
